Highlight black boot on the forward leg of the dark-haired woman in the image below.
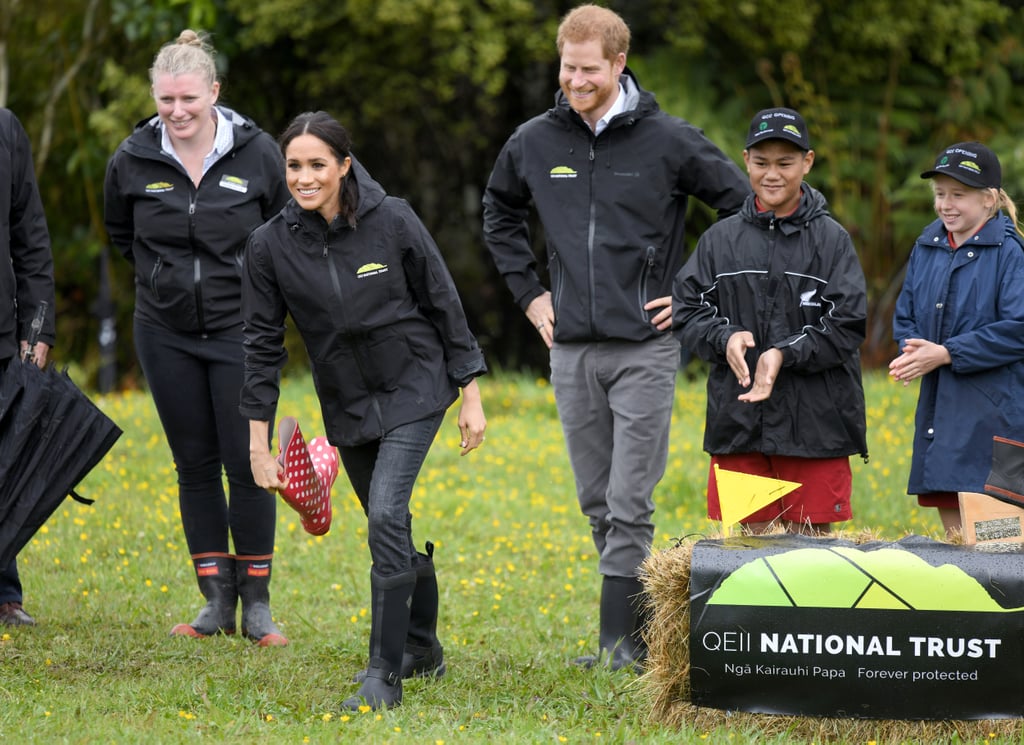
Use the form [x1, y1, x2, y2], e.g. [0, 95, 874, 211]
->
[341, 569, 416, 711]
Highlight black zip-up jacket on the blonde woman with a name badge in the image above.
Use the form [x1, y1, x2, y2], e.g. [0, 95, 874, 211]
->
[103, 106, 289, 334]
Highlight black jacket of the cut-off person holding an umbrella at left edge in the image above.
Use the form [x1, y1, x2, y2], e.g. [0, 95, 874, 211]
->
[0, 108, 55, 360]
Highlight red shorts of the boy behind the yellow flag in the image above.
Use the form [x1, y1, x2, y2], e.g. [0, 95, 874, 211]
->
[708, 452, 853, 524]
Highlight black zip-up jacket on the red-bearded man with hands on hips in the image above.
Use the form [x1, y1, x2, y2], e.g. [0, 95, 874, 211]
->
[483, 69, 750, 342]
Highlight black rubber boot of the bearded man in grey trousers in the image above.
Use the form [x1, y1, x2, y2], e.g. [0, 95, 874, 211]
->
[573, 576, 648, 672]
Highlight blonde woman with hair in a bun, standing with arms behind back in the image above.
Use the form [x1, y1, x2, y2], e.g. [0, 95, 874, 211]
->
[103, 30, 288, 647]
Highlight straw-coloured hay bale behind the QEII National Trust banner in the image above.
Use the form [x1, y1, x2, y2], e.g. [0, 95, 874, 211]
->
[638, 531, 1024, 745]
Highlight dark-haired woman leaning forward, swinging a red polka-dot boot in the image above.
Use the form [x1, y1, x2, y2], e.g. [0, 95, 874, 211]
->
[241, 112, 486, 710]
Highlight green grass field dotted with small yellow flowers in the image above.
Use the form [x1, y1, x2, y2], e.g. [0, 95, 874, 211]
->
[0, 374, 1015, 744]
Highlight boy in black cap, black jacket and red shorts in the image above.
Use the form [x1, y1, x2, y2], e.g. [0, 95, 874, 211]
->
[672, 108, 867, 534]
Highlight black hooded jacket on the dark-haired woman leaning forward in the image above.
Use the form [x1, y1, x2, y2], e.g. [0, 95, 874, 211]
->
[240, 158, 486, 445]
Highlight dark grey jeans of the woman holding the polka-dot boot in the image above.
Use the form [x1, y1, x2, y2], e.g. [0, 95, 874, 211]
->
[338, 411, 444, 576]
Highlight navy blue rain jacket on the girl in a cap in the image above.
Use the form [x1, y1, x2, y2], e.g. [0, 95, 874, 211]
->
[893, 212, 1024, 494]
